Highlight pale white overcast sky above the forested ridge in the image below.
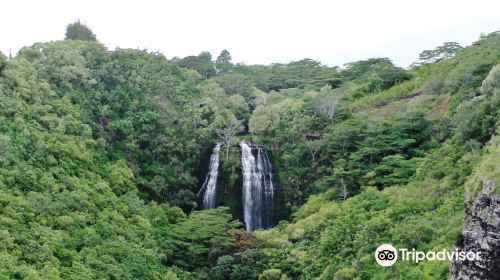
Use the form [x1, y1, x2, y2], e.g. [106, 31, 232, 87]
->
[0, 0, 500, 67]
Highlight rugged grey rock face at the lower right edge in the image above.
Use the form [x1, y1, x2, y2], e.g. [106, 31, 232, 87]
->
[449, 180, 500, 280]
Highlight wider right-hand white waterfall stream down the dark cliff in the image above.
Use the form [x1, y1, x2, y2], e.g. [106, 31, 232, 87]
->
[240, 141, 274, 231]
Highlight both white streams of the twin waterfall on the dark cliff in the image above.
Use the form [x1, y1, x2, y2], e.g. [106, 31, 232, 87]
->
[202, 141, 274, 231]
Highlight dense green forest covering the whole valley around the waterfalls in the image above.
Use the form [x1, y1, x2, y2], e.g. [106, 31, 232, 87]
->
[0, 22, 500, 280]
